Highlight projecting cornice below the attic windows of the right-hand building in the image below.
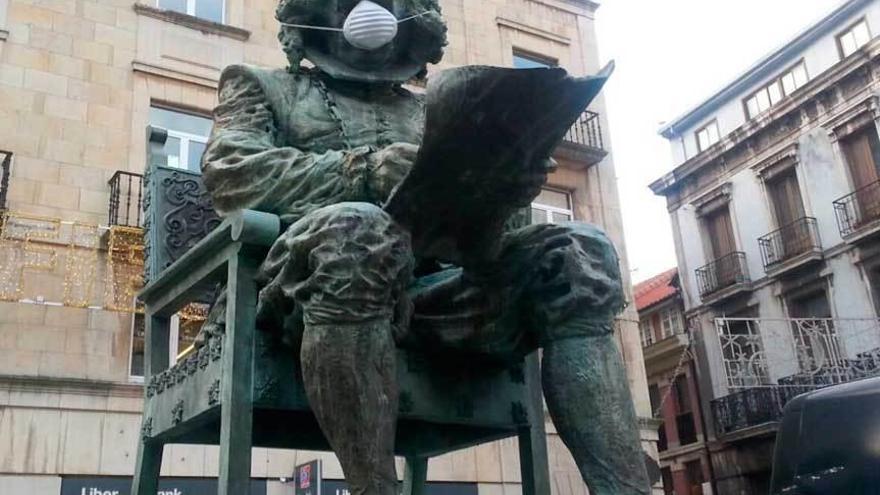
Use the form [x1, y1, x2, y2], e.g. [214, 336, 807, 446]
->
[649, 39, 880, 202]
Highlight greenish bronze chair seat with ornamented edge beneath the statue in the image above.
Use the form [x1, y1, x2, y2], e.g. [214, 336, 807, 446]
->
[144, 332, 529, 456]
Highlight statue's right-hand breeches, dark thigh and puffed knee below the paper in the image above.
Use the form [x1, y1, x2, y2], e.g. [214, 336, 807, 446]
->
[407, 222, 624, 358]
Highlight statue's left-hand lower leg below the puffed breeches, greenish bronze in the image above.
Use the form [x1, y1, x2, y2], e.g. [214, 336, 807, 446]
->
[301, 320, 398, 495]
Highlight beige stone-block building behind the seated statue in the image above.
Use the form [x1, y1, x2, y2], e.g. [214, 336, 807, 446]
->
[0, 0, 656, 495]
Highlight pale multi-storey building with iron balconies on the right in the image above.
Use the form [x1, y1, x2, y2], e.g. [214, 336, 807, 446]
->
[651, 0, 880, 494]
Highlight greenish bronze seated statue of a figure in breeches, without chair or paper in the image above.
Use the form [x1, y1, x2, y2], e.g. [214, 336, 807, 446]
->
[141, 0, 650, 495]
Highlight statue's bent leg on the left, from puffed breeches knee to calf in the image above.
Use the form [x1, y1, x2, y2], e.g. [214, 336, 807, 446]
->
[260, 203, 412, 495]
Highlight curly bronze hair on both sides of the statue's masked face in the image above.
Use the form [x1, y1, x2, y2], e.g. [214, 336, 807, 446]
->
[275, 0, 446, 69]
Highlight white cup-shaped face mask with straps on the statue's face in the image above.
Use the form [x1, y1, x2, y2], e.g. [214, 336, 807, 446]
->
[281, 0, 429, 50]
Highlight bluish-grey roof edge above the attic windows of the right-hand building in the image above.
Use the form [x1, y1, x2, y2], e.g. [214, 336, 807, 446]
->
[660, 0, 872, 139]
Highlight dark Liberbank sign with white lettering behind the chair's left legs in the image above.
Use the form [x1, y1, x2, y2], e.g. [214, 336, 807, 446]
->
[61, 476, 266, 495]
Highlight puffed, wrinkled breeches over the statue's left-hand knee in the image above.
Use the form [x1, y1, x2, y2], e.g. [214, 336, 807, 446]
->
[258, 203, 412, 331]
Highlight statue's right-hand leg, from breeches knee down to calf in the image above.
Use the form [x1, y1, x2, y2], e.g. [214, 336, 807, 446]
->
[504, 223, 650, 495]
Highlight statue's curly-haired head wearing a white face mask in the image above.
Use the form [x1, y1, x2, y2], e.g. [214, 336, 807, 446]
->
[276, 0, 446, 83]
